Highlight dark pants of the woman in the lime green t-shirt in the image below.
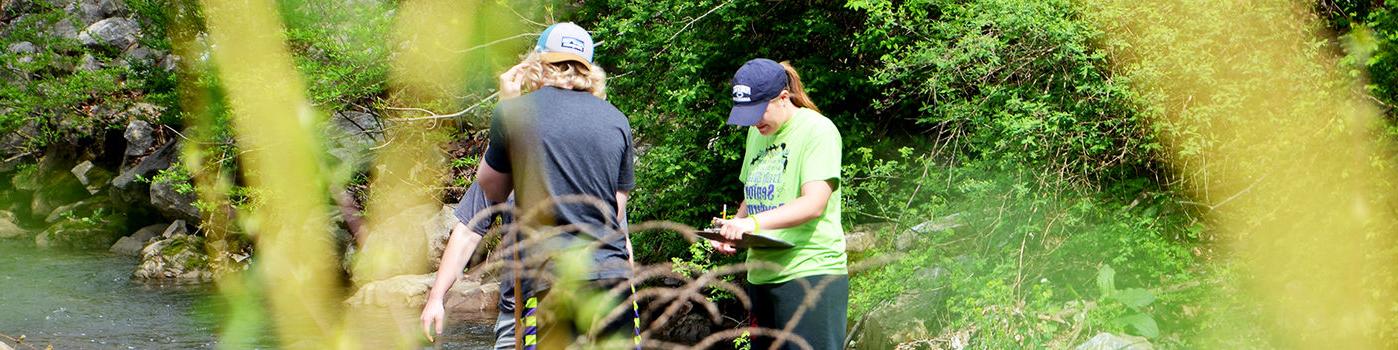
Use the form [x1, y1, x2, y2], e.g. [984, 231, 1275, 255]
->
[748, 274, 850, 350]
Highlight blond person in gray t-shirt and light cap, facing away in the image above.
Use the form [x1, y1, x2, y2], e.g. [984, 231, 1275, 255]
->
[477, 22, 639, 349]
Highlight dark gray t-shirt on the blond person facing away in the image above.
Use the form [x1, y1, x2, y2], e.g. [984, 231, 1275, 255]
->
[485, 87, 636, 280]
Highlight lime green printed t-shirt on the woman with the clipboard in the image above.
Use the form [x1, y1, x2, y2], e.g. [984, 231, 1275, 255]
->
[738, 108, 849, 284]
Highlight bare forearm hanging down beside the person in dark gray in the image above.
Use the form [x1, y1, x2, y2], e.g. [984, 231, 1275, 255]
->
[421, 223, 481, 342]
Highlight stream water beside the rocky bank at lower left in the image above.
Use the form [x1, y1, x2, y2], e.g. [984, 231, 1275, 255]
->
[0, 239, 492, 349]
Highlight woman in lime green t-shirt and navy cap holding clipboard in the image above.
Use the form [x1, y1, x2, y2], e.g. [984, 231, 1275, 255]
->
[713, 59, 850, 350]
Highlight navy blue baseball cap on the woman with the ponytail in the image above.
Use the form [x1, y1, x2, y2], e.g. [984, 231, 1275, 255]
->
[728, 59, 787, 126]
